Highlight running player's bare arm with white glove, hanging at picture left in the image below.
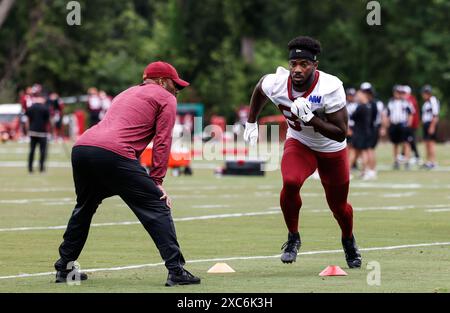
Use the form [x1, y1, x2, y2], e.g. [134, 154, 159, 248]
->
[244, 76, 268, 145]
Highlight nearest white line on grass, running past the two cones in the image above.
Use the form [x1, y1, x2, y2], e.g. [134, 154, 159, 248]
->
[0, 242, 450, 280]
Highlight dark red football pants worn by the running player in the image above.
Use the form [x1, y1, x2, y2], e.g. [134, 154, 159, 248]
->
[280, 138, 353, 238]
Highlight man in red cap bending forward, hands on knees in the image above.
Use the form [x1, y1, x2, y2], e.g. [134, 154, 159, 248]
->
[55, 61, 200, 286]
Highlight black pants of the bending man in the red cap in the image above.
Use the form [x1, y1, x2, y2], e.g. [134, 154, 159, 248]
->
[55, 146, 185, 272]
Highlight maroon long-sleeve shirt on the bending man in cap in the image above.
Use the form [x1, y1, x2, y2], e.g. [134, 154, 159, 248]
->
[75, 84, 177, 185]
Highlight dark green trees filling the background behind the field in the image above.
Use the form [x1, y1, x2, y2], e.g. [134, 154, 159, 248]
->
[0, 0, 450, 117]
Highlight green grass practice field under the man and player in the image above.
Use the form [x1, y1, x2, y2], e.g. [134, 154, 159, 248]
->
[0, 143, 450, 293]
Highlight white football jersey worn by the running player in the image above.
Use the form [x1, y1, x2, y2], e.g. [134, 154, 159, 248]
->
[262, 66, 347, 152]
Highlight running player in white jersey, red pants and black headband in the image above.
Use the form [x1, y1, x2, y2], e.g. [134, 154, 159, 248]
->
[244, 36, 361, 268]
